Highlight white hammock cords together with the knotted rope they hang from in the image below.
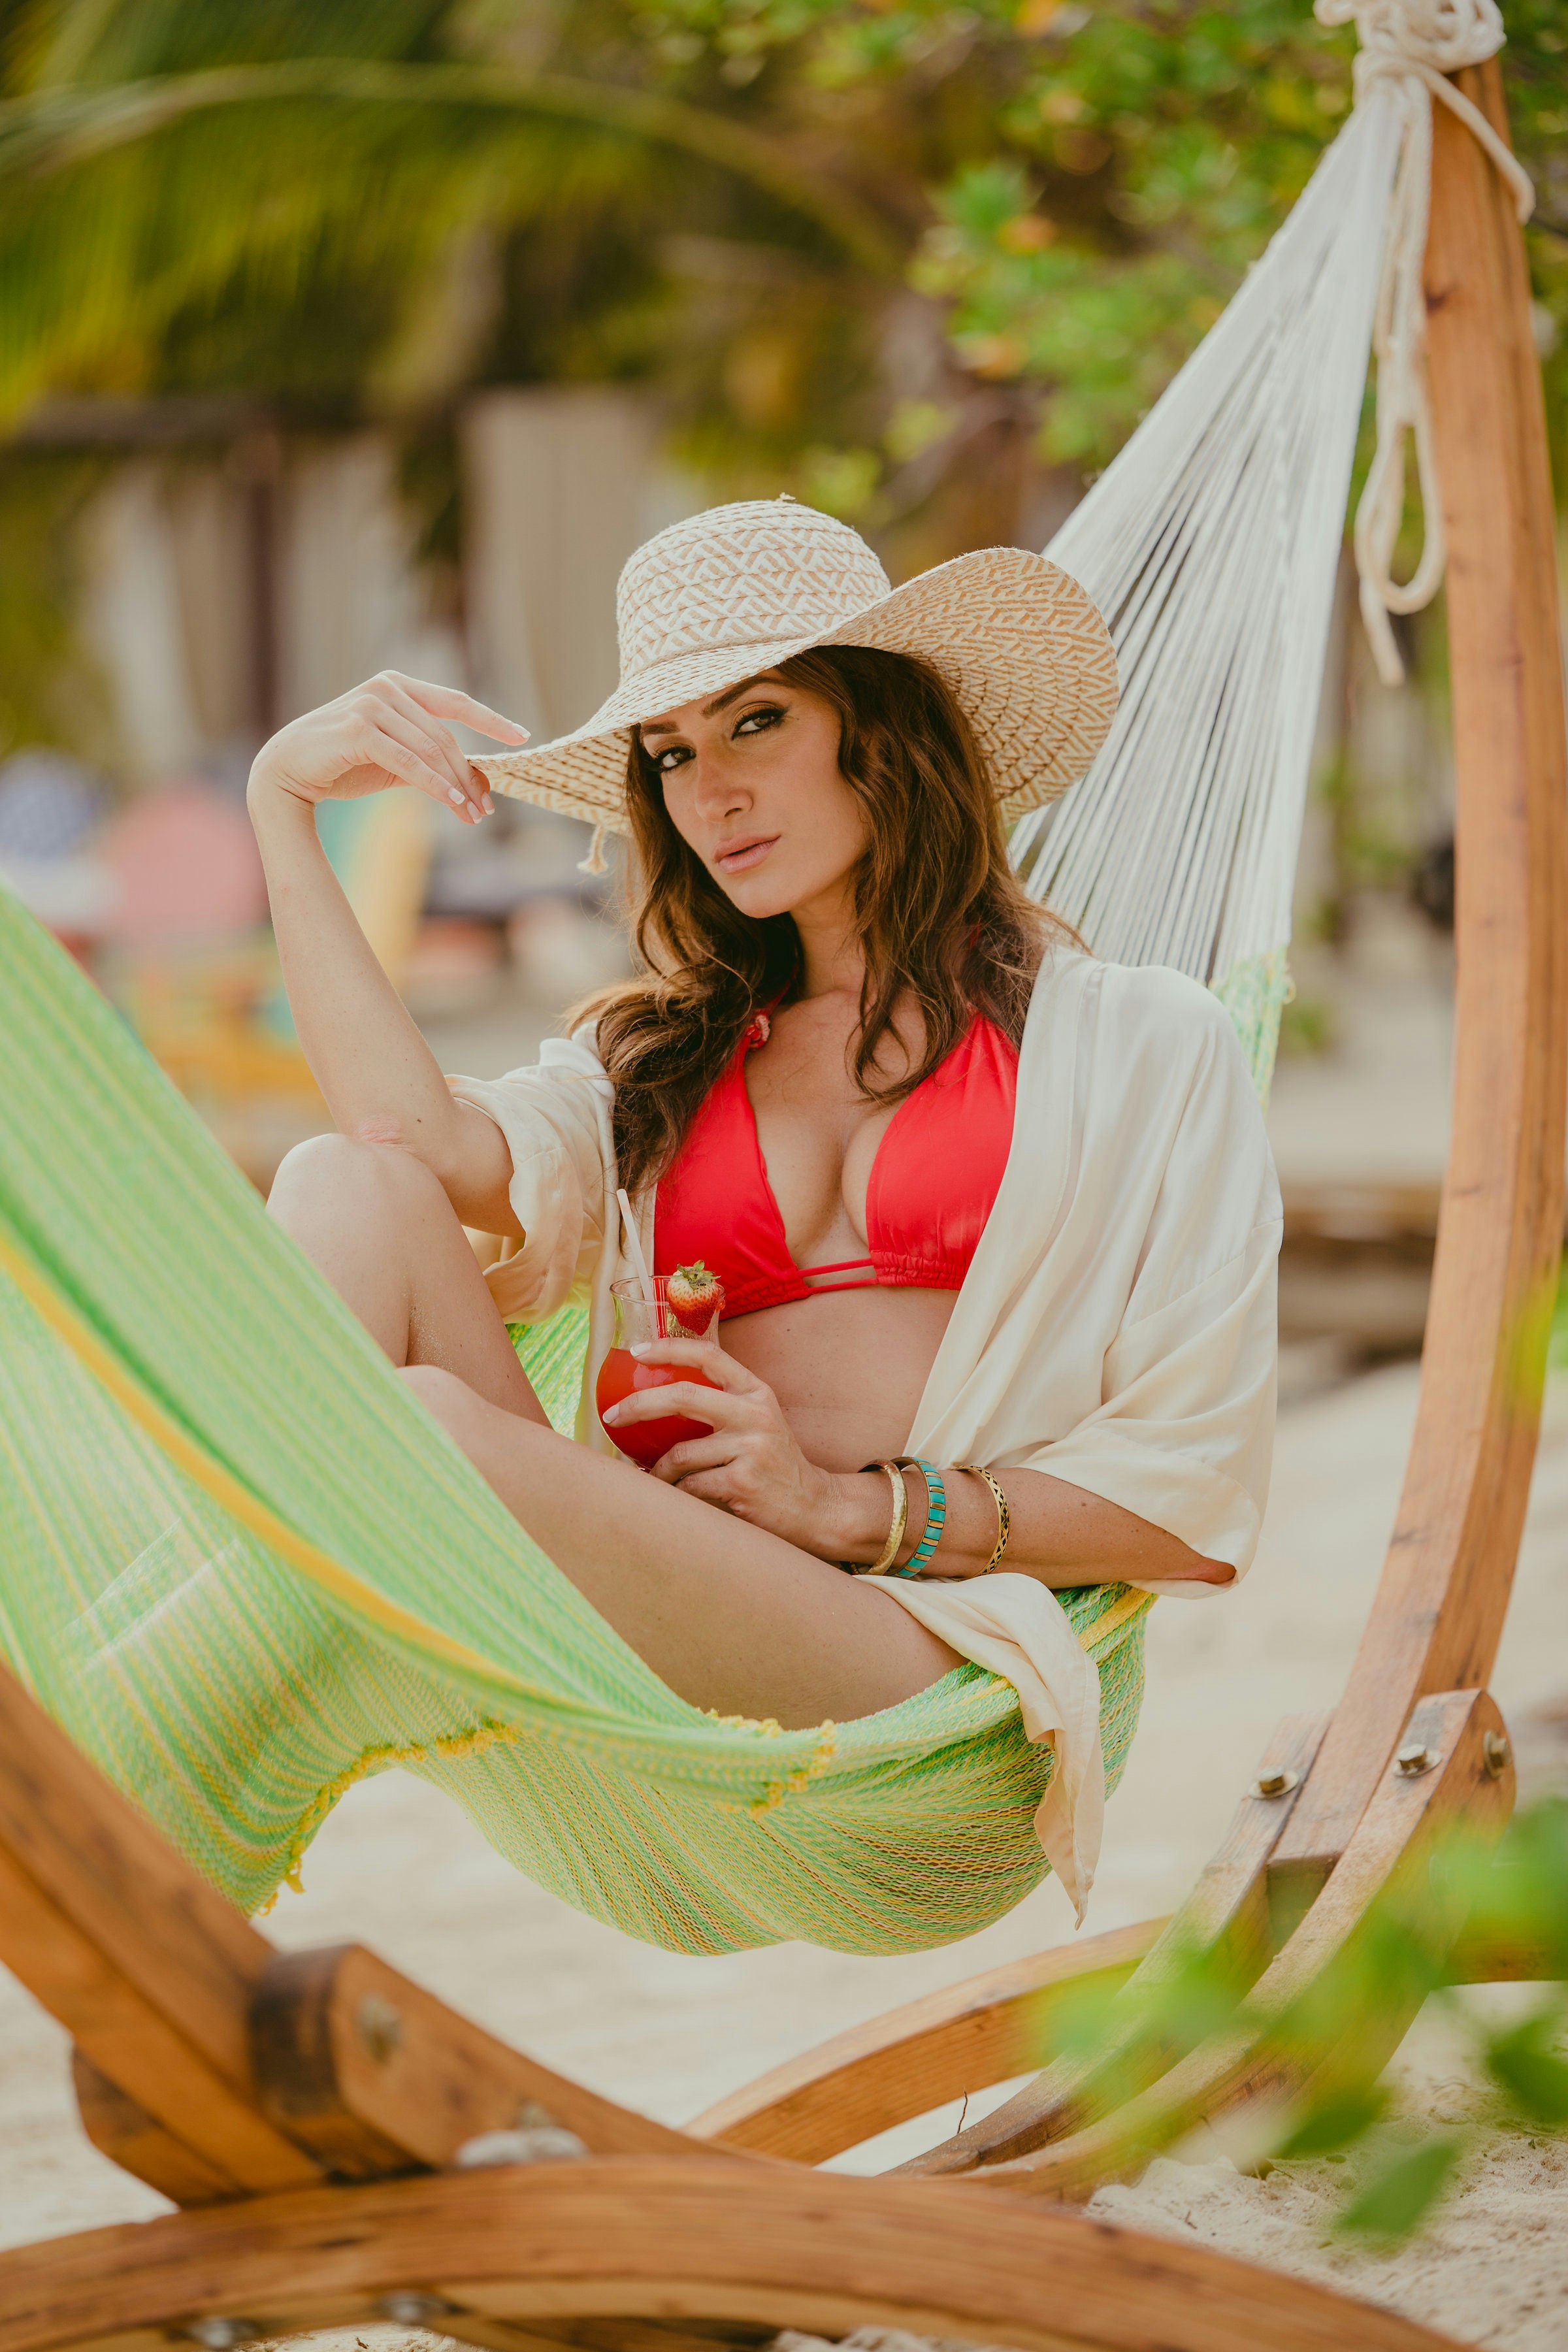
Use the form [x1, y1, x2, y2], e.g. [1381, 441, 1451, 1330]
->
[1013, 0, 1533, 1094]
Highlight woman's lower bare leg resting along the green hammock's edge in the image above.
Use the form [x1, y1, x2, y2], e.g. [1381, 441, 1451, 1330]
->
[404, 1364, 959, 1726]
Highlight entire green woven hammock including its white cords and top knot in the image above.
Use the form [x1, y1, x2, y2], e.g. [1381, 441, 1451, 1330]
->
[0, 0, 1502, 1952]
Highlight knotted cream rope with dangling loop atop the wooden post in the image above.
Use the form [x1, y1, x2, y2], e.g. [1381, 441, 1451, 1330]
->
[1314, 0, 1535, 687]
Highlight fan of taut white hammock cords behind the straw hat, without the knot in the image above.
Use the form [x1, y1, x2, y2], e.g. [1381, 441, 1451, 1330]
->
[1030, 106, 1401, 981]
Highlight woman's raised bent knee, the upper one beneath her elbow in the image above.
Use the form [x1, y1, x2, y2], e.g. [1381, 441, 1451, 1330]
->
[268, 1136, 546, 1423]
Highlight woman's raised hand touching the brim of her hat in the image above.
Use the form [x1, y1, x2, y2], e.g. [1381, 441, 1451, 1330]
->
[252, 670, 529, 826]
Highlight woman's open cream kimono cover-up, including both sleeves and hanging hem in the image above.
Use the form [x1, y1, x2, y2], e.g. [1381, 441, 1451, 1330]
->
[449, 950, 1281, 1917]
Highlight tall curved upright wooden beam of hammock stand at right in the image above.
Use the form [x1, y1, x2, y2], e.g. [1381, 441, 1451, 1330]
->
[1277, 59, 1568, 1870]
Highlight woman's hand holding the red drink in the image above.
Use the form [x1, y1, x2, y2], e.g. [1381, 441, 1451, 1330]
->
[604, 1338, 865, 1560]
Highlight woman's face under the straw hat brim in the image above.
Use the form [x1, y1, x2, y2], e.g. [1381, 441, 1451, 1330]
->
[640, 670, 870, 917]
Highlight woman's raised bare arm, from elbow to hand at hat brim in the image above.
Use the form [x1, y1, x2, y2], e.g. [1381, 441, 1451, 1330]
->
[249, 670, 527, 1232]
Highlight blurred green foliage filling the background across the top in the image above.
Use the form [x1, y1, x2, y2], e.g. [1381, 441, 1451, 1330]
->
[0, 0, 1568, 743]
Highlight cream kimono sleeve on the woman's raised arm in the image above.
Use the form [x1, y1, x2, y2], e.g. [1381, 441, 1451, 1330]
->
[447, 1032, 616, 1322]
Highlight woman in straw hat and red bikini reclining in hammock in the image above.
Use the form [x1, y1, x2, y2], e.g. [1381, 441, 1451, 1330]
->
[252, 501, 1279, 1893]
